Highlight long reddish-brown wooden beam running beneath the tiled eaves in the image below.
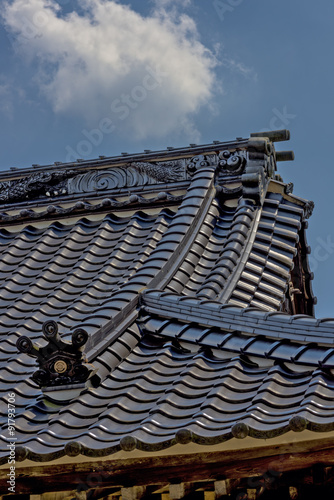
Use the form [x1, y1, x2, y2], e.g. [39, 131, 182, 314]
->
[4, 439, 334, 494]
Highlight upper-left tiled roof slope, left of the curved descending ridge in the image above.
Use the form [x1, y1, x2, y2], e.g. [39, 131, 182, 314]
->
[0, 209, 174, 340]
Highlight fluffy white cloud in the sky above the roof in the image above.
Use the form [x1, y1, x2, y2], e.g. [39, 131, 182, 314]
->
[2, 0, 217, 138]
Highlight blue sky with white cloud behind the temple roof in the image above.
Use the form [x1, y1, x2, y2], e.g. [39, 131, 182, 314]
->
[0, 0, 334, 317]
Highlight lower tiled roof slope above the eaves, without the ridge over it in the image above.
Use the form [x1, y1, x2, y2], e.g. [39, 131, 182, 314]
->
[1, 334, 334, 460]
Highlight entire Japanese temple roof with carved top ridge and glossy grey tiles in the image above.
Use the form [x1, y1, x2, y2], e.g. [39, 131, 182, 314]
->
[0, 131, 334, 463]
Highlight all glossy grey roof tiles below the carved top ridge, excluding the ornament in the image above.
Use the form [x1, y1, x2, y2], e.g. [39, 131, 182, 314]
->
[0, 146, 326, 460]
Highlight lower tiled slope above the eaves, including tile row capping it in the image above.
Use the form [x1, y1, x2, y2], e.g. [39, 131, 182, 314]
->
[0, 310, 334, 461]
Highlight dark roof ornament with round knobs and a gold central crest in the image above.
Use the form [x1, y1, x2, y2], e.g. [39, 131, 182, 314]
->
[16, 321, 96, 389]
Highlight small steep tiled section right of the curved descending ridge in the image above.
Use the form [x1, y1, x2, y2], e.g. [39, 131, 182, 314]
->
[166, 193, 303, 310]
